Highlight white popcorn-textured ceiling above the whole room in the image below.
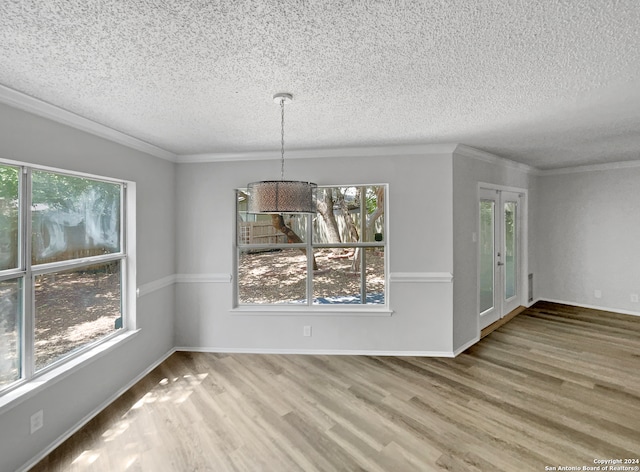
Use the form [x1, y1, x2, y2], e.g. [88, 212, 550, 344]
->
[0, 0, 640, 169]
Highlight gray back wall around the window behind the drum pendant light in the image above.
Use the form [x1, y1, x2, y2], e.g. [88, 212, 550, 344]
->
[176, 153, 453, 353]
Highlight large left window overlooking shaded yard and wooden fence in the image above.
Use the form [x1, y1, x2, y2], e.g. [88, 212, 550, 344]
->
[0, 163, 127, 390]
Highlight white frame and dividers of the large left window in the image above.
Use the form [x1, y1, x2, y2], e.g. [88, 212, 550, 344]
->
[0, 159, 138, 398]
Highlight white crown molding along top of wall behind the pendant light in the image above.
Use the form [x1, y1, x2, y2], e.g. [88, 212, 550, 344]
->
[177, 143, 458, 164]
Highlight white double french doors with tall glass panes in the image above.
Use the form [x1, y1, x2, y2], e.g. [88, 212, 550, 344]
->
[478, 188, 522, 329]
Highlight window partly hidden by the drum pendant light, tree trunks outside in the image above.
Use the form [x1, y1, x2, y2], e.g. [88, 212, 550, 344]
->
[236, 185, 387, 306]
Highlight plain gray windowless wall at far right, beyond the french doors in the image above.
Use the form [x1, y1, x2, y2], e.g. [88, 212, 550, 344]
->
[535, 166, 640, 314]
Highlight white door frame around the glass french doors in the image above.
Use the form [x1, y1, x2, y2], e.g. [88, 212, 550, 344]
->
[474, 182, 529, 334]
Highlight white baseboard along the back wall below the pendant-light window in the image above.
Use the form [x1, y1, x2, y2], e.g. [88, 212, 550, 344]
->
[175, 346, 454, 357]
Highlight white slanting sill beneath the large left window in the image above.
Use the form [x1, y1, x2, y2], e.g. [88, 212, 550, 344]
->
[0, 329, 140, 415]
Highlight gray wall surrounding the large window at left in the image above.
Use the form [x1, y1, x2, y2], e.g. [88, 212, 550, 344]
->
[0, 105, 175, 471]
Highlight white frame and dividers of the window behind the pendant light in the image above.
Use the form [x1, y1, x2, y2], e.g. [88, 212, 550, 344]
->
[231, 183, 393, 316]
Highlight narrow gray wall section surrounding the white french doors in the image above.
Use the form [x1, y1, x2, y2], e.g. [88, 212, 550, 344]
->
[453, 148, 535, 351]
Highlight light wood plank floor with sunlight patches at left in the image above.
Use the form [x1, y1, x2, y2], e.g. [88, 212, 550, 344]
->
[32, 302, 640, 472]
